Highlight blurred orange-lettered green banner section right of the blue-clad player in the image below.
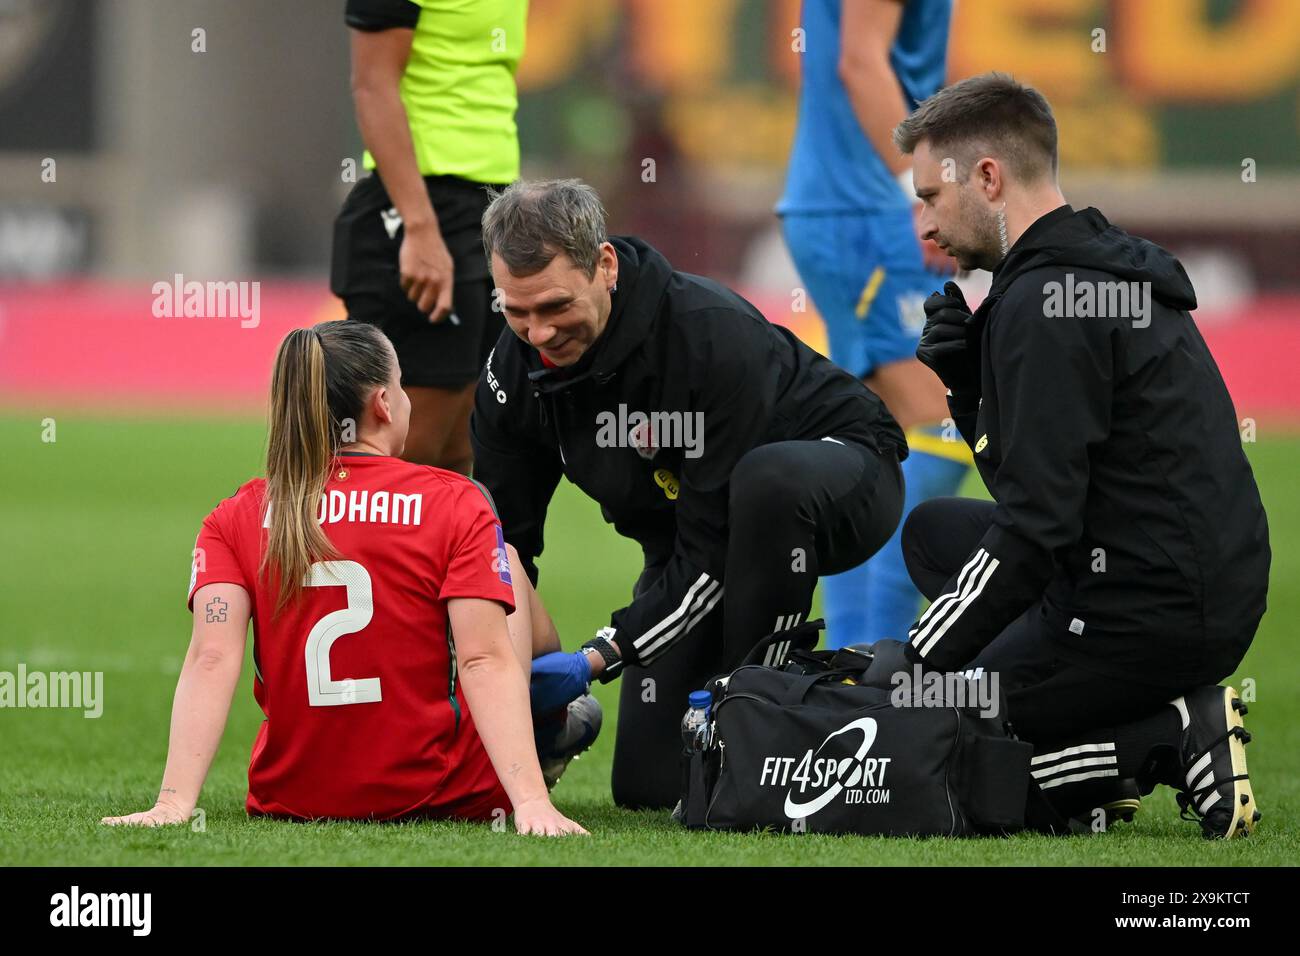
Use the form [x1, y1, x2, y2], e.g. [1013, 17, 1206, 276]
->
[952, 0, 1300, 170]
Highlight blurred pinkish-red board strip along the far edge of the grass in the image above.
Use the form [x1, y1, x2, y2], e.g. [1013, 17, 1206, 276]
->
[0, 276, 1300, 427]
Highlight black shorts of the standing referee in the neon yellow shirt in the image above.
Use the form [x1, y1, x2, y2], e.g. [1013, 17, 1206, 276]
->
[330, 173, 504, 389]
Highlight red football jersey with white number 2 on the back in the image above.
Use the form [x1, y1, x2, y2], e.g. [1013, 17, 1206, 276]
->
[190, 455, 515, 819]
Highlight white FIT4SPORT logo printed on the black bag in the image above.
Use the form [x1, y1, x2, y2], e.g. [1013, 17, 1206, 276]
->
[758, 717, 893, 819]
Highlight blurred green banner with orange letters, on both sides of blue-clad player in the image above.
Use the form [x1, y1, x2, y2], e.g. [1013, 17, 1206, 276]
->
[519, 0, 1300, 170]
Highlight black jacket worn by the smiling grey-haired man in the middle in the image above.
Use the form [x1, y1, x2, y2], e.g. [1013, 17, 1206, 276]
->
[471, 237, 907, 679]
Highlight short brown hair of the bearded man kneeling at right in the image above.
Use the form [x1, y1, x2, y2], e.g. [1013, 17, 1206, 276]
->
[893, 73, 1057, 182]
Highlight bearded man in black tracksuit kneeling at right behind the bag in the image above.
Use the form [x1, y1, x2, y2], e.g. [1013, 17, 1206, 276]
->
[894, 74, 1270, 836]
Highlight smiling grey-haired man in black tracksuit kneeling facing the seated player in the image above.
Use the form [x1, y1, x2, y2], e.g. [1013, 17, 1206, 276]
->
[471, 183, 906, 806]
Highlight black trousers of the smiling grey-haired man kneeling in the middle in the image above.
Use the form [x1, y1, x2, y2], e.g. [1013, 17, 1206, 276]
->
[611, 438, 904, 809]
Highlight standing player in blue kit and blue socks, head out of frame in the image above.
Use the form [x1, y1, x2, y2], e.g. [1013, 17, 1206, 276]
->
[776, 0, 971, 646]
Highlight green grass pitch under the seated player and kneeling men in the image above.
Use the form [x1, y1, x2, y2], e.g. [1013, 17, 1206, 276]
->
[0, 412, 1300, 866]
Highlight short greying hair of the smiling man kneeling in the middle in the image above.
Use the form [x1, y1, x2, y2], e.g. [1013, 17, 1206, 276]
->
[482, 179, 607, 278]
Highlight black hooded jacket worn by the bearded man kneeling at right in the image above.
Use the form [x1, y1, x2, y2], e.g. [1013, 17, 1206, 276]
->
[910, 206, 1270, 684]
